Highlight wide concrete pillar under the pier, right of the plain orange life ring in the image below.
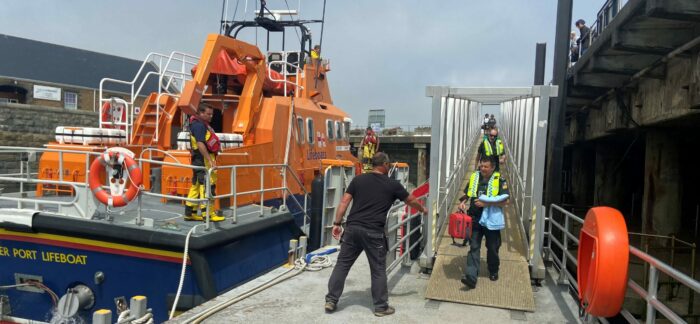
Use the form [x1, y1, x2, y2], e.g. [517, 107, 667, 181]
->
[642, 130, 681, 235]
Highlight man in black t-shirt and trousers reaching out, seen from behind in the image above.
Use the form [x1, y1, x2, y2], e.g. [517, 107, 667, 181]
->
[325, 152, 426, 316]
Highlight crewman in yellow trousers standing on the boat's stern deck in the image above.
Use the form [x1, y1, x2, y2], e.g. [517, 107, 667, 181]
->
[185, 105, 224, 222]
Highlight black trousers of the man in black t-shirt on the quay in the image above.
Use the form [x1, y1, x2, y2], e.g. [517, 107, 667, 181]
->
[326, 226, 389, 310]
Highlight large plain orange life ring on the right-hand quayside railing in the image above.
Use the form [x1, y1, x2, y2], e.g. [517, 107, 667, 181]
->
[576, 207, 629, 317]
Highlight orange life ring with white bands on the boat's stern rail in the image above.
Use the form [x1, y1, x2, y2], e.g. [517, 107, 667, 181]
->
[88, 150, 143, 207]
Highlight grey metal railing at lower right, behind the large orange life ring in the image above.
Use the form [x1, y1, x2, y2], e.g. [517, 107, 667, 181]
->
[543, 204, 700, 323]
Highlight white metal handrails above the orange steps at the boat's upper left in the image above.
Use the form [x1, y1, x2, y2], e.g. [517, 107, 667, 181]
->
[99, 51, 199, 144]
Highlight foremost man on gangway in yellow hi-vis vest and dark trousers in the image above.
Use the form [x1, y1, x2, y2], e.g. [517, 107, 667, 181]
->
[459, 156, 509, 289]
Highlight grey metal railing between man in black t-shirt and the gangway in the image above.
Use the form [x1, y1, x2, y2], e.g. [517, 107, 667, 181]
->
[386, 194, 428, 273]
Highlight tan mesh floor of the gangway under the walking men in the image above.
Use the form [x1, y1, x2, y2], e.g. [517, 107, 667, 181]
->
[425, 149, 535, 312]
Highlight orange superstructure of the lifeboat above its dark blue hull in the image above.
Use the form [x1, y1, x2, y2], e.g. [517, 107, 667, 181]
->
[38, 29, 357, 207]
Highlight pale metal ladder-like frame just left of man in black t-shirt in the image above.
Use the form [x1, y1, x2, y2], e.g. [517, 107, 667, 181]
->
[321, 165, 355, 246]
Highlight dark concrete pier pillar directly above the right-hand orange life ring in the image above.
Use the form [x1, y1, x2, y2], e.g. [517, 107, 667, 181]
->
[592, 143, 625, 211]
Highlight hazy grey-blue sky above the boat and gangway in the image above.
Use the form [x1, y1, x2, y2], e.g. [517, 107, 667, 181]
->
[0, 0, 605, 126]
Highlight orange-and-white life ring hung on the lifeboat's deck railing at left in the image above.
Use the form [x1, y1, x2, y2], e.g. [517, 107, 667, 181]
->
[88, 147, 143, 207]
